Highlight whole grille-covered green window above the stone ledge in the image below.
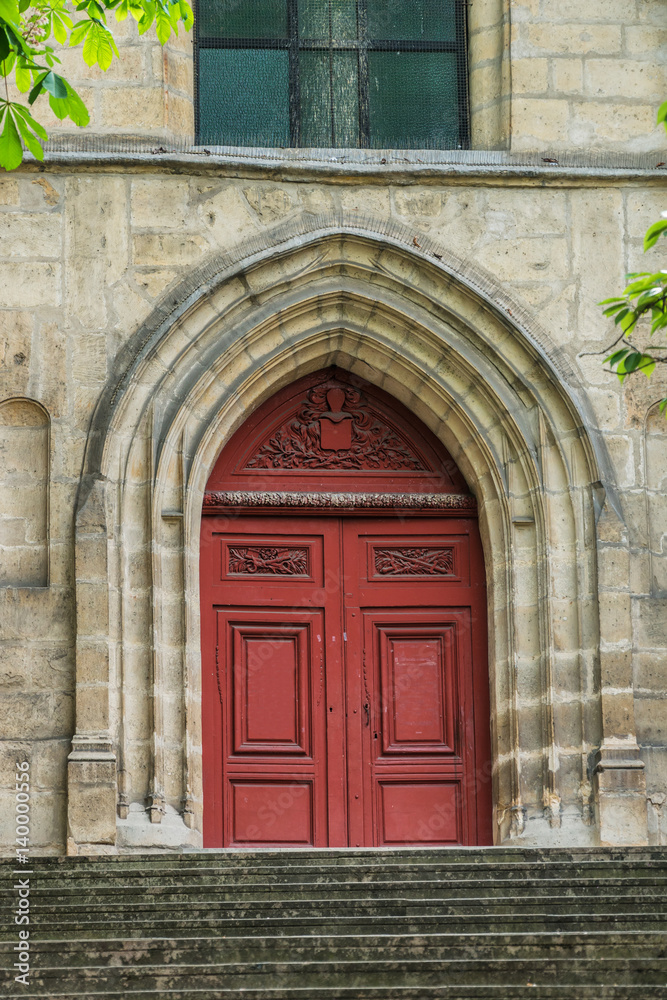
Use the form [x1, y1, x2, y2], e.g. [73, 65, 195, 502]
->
[195, 0, 469, 149]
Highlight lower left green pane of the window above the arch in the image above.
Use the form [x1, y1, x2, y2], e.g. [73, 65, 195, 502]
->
[199, 49, 290, 146]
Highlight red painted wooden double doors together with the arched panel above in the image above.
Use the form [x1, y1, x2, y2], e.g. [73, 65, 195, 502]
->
[200, 371, 491, 847]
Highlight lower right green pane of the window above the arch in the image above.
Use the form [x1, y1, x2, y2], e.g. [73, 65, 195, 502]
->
[368, 52, 459, 149]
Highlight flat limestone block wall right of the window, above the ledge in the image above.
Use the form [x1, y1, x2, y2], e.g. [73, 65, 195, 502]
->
[510, 0, 667, 152]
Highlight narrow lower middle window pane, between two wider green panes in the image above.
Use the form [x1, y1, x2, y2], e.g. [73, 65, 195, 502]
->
[299, 51, 359, 146]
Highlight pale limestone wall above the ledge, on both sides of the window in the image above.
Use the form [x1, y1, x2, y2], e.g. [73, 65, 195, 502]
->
[11, 0, 667, 154]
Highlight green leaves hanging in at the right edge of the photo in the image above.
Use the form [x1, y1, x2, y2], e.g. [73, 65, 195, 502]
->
[598, 101, 667, 416]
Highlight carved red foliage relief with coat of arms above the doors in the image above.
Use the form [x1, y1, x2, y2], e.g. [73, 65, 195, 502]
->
[245, 379, 429, 472]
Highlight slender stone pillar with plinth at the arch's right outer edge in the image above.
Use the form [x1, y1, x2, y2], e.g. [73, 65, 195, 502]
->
[595, 501, 648, 846]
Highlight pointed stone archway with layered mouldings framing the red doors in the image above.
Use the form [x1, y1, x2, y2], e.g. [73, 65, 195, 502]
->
[69, 220, 645, 851]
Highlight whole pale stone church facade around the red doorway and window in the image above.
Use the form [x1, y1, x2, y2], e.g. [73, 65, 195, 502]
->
[0, 0, 667, 854]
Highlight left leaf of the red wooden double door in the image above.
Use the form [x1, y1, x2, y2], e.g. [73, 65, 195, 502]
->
[201, 519, 340, 847]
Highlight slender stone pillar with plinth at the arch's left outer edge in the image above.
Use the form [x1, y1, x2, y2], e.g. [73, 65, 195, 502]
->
[67, 481, 117, 854]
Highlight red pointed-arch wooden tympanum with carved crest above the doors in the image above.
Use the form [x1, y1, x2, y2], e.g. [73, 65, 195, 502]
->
[206, 368, 469, 493]
